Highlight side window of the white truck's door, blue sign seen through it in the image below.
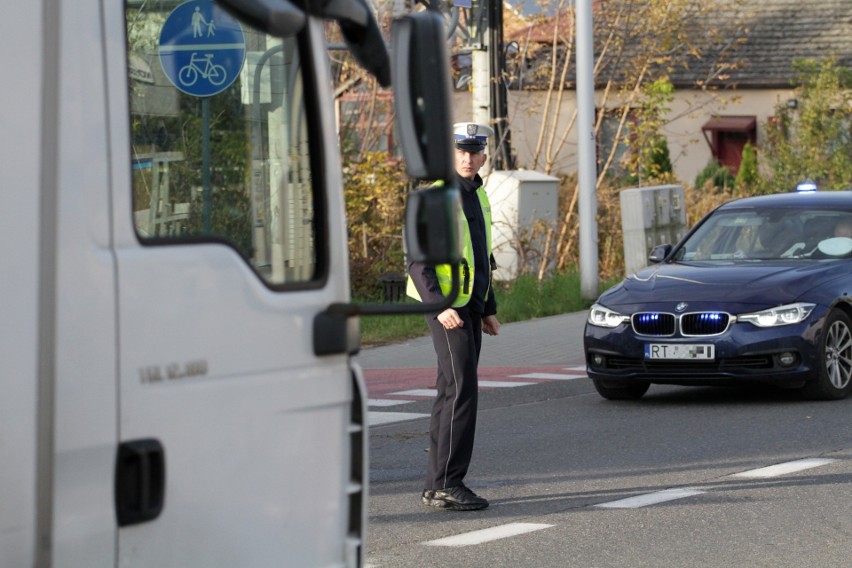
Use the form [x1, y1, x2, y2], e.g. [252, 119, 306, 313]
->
[125, 0, 322, 286]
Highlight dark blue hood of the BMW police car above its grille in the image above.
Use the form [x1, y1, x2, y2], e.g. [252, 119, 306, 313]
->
[600, 261, 849, 307]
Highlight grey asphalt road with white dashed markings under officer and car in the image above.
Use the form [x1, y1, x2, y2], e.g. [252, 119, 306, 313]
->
[352, 314, 852, 568]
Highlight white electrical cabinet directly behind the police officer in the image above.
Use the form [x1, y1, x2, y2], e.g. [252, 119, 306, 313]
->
[485, 170, 559, 281]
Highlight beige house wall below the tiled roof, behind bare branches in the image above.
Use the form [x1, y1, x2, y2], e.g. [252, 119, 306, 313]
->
[453, 89, 794, 185]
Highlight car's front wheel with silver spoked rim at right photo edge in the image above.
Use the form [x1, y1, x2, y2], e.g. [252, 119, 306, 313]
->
[803, 310, 852, 400]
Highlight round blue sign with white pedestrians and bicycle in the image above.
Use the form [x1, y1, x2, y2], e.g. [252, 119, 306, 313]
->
[159, 0, 246, 97]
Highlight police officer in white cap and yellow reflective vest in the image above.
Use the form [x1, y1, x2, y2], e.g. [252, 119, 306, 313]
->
[407, 122, 500, 511]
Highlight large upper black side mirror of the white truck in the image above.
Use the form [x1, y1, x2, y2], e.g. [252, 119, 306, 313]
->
[391, 10, 453, 180]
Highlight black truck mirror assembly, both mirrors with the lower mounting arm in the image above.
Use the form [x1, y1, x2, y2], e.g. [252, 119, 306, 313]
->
[312, 7, 461, 356]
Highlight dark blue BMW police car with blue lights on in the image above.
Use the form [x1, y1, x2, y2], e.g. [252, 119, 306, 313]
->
[584, 187, 852, 400]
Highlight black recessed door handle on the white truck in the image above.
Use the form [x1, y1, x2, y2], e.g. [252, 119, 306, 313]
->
[115, 438, 166, 527]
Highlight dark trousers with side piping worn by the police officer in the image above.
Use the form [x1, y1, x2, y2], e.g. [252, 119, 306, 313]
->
[425, 308, 482, 489]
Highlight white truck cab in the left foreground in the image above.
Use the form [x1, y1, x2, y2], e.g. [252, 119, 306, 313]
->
[0, 0, 457, 568]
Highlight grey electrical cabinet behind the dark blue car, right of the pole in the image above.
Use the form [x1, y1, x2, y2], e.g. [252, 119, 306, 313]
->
[621, 185, 687, 275]
